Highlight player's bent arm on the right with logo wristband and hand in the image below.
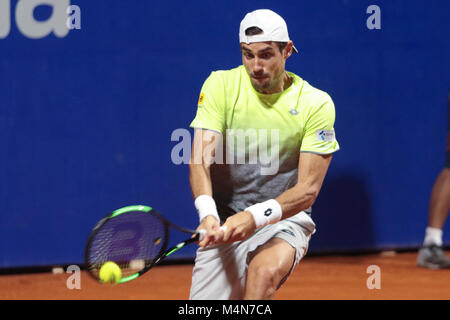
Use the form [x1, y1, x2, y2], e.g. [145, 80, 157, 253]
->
[218, 152, 332, 243]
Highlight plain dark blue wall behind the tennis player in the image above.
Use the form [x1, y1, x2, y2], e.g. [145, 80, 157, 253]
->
[0, 0, 450, 267]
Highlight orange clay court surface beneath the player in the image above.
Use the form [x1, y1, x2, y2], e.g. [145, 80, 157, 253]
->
[0, 252, 450, 300]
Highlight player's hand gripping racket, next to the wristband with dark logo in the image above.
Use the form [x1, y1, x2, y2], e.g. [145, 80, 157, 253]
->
[215, 211, 256, 244]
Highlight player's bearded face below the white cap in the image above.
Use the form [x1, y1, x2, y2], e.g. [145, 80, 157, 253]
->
[241, 42, 287, 94]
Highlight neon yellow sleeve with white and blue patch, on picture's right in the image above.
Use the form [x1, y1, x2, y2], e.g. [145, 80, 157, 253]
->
[300, 95, 339, 154]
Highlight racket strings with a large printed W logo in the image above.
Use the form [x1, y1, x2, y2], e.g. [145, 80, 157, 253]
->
[87, 212, 166, 277]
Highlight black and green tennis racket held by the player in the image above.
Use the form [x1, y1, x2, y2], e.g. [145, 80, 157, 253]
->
[84, 205, 205, 283]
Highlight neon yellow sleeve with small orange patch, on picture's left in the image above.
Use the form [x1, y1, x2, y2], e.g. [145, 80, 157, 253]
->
[190, 72, 225, 133]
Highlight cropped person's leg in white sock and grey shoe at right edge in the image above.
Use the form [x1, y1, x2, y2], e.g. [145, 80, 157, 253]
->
[417, 95, 450, 269]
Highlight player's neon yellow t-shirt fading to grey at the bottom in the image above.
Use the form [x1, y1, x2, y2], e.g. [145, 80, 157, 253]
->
[191, 65, 339, 222]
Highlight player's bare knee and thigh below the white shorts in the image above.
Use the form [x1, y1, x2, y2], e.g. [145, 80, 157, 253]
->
[244, 238, 296, 300]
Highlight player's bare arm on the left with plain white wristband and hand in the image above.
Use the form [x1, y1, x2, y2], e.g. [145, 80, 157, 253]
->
[189, 129, 222, 247]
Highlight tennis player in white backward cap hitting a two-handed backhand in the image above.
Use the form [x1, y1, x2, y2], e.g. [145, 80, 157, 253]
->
[190, 9, 339, 299]
